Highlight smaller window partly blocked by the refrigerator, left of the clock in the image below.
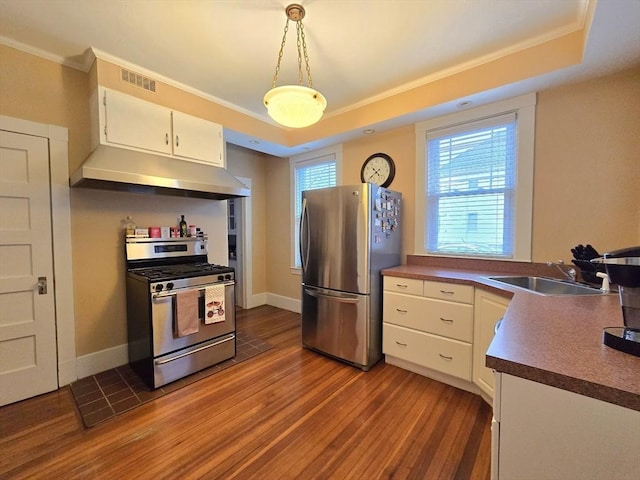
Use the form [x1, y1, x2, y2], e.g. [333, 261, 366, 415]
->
[290, 147, 342, 269]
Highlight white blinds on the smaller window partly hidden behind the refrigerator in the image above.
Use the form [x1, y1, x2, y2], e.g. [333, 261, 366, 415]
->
[295, 155, 336, 267]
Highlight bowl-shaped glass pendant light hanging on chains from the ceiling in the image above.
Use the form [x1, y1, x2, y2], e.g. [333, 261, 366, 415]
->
[264, 3, 327, 128]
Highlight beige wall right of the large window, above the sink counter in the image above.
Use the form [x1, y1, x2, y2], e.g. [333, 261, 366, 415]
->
[533, 68, 640, 262]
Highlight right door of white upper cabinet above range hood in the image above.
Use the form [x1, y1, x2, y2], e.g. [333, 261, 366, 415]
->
[173, 111, 224, 167]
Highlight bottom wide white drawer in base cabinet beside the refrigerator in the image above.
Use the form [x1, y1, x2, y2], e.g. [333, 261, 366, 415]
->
[382, 323, 471, 381]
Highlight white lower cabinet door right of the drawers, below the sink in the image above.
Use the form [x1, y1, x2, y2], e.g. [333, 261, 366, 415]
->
[473, 288, 509, 398]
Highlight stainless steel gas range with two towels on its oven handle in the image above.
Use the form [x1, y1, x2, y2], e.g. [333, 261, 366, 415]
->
[125, 236, 236, 389]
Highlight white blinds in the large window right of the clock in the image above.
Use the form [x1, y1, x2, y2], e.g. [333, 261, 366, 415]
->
[425, 113, 517, 258]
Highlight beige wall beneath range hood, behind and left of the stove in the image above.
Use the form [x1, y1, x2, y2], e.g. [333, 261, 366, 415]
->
[71, 188, 227, 356]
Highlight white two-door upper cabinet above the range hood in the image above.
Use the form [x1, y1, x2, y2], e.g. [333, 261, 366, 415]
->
[92, 87, 224, 167]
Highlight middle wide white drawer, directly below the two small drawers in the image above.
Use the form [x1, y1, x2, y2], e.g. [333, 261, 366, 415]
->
[382, 292, 473, 342]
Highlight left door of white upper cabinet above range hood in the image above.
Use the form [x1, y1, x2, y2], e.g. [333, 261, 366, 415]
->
[102, 90, 171, 154]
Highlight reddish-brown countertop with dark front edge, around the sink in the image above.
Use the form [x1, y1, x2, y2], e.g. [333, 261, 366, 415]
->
[382, 264, 640, 411]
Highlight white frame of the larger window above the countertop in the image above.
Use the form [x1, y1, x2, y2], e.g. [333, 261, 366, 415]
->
[414, 93, 537, 262]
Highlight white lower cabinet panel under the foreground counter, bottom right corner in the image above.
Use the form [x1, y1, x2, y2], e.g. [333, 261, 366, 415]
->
[492, 373, 640, 480]
